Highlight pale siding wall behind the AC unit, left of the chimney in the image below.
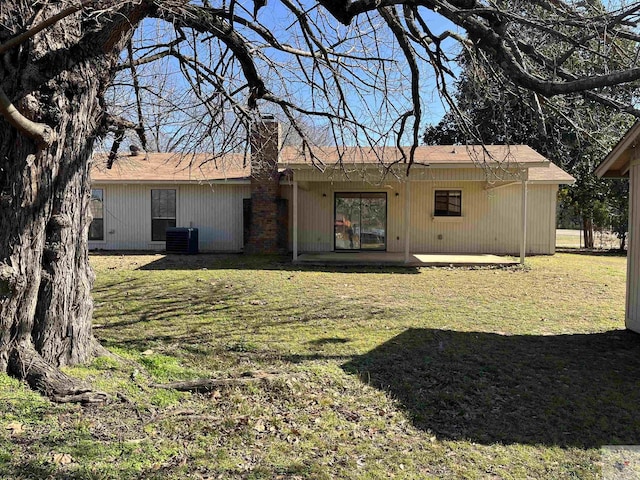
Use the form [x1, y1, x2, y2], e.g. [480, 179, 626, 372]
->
[89, 184, 250, 251]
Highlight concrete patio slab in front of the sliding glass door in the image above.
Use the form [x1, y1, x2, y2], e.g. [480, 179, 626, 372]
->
[293, 252, 519, 267]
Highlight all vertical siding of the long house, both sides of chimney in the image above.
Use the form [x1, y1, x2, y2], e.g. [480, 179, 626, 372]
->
[90, 178, 558, 254]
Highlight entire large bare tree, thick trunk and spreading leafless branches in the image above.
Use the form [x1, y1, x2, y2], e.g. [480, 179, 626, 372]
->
[0, 0, 640, 399]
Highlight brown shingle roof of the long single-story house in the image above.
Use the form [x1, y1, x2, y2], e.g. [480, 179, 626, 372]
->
[91, 145, 574, 183]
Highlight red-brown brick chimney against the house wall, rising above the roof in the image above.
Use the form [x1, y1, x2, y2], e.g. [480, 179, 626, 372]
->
[245, 116, 289, 254]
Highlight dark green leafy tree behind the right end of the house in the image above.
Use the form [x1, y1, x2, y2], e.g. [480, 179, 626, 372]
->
[424, 32, 633, 248]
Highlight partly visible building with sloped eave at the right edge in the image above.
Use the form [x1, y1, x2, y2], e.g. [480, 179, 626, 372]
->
[596, 121, 640, 333]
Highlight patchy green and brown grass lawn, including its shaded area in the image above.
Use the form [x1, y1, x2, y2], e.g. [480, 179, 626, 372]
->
[0, 254, 640, 479]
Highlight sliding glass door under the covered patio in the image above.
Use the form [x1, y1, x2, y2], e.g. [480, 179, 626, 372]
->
[334, 192, 387, 250]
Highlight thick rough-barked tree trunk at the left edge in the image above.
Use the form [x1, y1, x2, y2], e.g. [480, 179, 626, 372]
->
[0, 0, 142, 398]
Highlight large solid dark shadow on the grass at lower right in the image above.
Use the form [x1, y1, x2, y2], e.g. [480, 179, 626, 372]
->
[342, 329, 640, 448]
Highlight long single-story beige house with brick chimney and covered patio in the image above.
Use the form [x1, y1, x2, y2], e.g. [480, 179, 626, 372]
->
[89, 120, 574, 260]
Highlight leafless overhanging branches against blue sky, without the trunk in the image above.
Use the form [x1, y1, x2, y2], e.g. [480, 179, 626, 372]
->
[84, 0, 640, 170]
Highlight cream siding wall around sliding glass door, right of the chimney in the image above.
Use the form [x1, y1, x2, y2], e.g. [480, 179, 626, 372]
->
[285, 181, 558, 255]
